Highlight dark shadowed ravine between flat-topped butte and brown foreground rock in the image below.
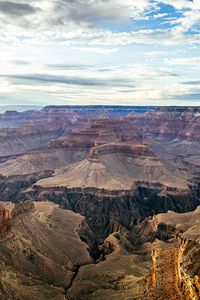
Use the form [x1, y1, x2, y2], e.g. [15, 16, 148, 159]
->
[20, 186, 200, 240]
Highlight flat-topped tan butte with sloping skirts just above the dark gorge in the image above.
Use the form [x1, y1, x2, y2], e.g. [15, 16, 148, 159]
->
[37, 143, 191, 193]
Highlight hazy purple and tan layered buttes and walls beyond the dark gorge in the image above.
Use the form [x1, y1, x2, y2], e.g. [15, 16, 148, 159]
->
[0, 107, 200, 193]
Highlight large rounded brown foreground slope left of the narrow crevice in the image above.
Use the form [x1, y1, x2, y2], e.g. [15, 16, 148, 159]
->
[0, 202, 92, 300]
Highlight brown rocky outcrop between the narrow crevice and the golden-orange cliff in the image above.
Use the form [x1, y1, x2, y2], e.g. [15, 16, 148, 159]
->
[66, 230, 150, 300]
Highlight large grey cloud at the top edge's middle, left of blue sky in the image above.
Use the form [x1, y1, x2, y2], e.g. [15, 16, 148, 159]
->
[51, 0, 151, 25]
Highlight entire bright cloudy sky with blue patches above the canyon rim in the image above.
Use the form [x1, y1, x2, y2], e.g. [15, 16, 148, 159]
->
[0, 0, 200, 106]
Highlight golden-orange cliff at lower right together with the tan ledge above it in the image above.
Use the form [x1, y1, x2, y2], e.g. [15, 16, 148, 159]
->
[142, 207, 200, 300]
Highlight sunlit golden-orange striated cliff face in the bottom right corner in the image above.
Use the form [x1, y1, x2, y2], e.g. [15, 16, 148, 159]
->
[147, 239, 200, 300]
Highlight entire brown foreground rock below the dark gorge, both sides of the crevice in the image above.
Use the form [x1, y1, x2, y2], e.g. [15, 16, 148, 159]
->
[0, 201, 200, 300]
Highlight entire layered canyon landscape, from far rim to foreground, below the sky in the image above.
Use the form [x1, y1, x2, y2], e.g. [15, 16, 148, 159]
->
[0, 105, 200, 300]
